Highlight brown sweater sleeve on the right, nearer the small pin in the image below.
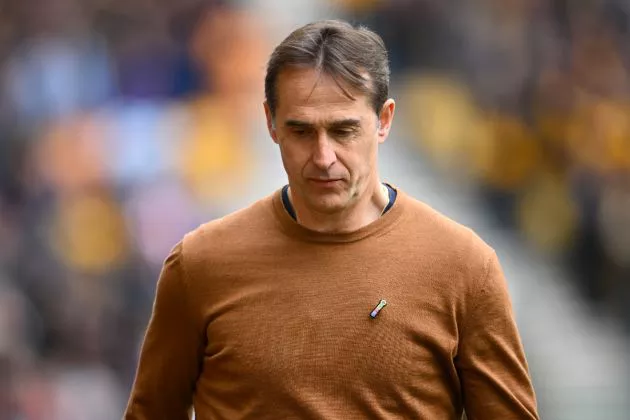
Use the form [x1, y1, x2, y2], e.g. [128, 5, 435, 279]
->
[456, 252, 538, 420]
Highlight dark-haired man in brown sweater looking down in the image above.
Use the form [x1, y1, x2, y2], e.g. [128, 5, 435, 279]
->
[125, 21, 538, 420]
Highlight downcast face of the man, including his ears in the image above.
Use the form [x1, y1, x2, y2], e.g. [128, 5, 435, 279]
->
[265, 68, 394, 214]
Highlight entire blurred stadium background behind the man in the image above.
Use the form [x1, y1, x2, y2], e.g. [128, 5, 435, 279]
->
[0, 0, 630, 420]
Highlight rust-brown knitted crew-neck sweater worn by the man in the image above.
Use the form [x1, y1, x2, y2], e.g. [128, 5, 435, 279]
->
[125, 190, 538, 420]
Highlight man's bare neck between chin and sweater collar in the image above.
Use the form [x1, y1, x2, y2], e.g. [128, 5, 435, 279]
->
[289, 179, 389, 233]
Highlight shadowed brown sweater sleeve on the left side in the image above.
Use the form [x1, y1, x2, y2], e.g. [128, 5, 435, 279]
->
[124, 243, 204, 420]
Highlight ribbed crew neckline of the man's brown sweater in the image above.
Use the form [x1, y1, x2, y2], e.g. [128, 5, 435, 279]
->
[272, 184, 407, 243]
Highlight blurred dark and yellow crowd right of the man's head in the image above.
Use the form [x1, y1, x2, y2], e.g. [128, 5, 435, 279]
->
[340, 0, 630, 331]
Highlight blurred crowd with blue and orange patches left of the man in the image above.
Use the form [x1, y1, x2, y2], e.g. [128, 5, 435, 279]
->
[0, 0, 270, 420]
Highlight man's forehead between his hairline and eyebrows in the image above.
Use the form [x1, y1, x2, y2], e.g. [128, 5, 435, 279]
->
[276, 68, 373, 120]
